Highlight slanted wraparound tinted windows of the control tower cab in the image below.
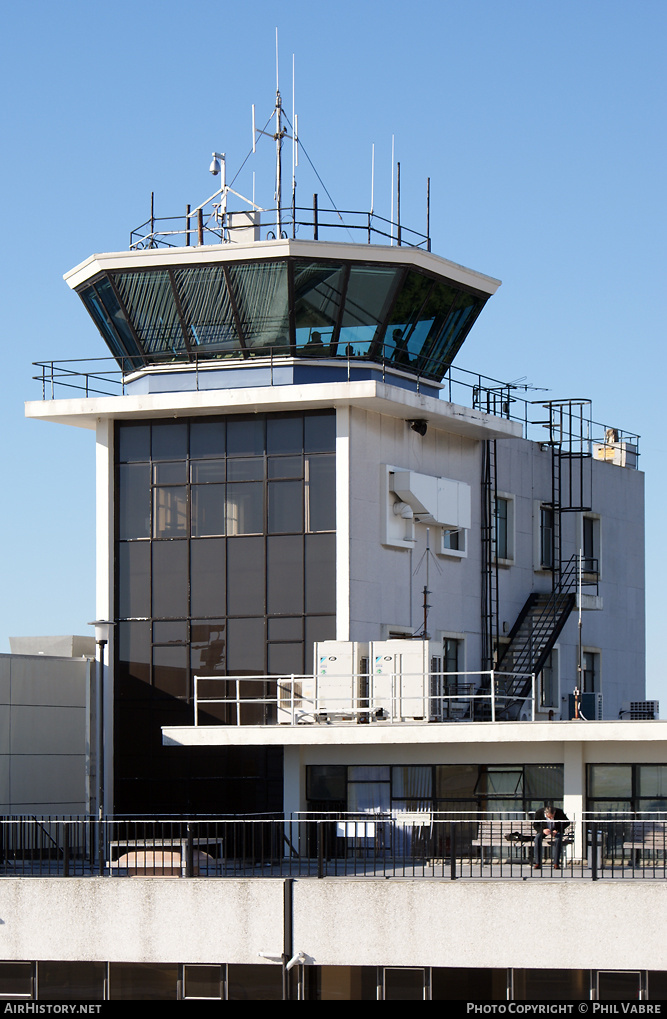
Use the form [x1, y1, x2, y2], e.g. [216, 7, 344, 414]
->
[78, 259, 488, 379]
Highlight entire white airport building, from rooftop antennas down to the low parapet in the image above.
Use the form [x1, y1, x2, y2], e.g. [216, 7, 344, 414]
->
[0, 104, 667, 1000]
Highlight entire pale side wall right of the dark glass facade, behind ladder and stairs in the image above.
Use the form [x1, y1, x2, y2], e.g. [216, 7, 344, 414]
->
[339, 408, 645, 718]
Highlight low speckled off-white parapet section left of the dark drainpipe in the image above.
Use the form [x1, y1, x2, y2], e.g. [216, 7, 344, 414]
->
[0, 877, 283, 963]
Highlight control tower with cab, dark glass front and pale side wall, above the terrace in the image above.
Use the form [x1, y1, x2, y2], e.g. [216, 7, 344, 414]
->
[27, 91, 644, 813]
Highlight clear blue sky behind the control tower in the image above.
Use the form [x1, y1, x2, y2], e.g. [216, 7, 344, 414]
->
[0, 0, 667, 701]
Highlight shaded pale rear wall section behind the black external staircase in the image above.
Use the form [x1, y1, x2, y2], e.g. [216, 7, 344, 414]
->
[497, 439, 646, 718]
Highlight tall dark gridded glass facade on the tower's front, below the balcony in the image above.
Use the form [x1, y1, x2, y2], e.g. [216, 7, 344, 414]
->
[115, 412, 335, 813]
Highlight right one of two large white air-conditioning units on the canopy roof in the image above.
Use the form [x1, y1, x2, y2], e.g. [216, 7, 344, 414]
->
[370, 639, 442, 721]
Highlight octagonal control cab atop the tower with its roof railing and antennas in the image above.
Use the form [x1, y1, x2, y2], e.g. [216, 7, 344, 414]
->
[65, 88, 499, 395]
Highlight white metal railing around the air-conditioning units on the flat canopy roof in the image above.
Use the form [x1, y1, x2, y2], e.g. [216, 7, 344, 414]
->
[190, 669, 536, 726]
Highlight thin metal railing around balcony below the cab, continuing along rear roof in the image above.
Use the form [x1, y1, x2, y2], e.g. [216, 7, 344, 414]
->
[33, 354, 640, 458]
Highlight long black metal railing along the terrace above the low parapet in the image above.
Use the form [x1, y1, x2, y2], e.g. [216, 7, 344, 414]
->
[0, 815, 667, 880]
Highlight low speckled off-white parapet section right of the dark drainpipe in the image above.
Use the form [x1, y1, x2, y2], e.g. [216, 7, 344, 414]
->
[293, 878, 667, 969]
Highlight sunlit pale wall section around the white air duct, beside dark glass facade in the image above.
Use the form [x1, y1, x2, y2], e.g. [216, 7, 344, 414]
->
[349, 409, 482, 668]
